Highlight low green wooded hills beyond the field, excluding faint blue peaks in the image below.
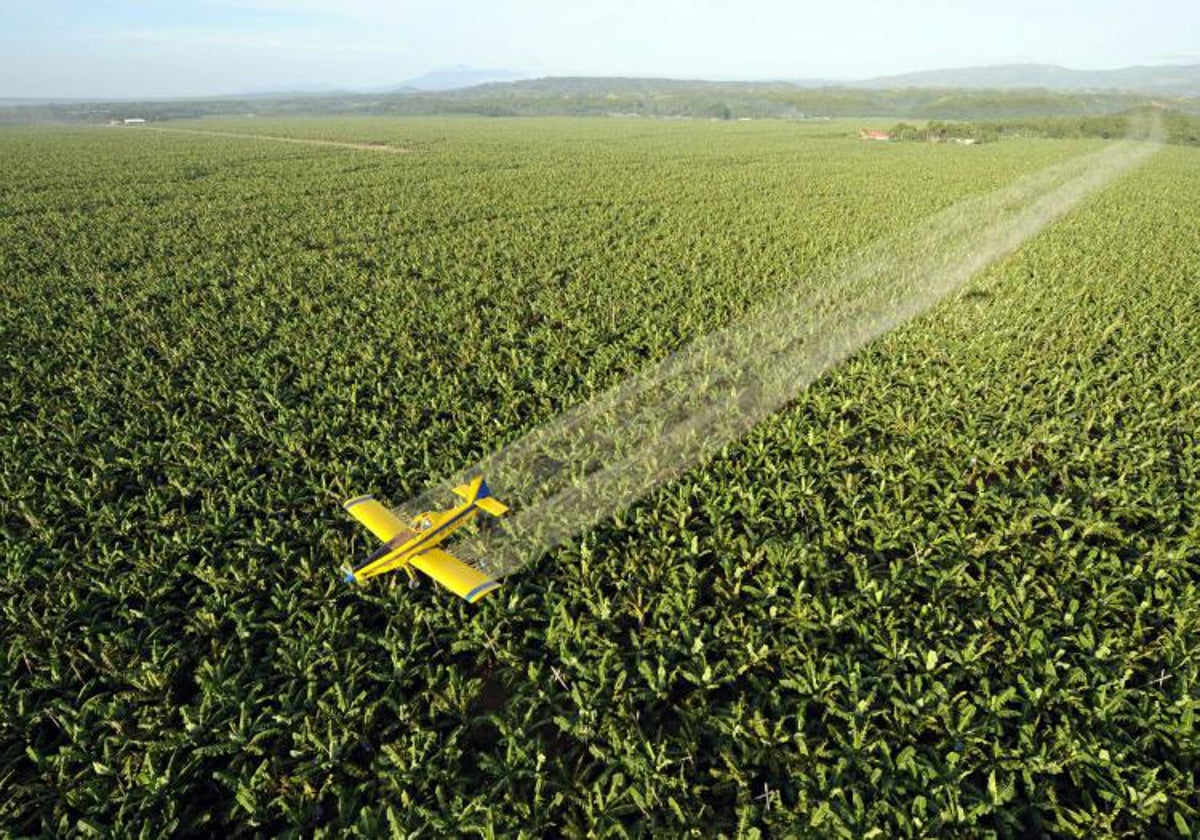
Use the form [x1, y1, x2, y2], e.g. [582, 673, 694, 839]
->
[0, 78, 1200, 122]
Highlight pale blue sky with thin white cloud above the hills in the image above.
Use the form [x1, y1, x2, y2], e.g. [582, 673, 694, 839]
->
[0, 0, 1200, 98]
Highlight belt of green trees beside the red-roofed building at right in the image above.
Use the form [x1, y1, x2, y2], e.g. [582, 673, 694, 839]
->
[889, 109, 1200, 145]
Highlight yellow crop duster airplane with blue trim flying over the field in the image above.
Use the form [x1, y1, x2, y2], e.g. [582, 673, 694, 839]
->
[343, 475, 509, 604]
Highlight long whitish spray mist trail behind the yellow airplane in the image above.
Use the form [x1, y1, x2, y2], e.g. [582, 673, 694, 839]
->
[397, 142, 1158, 576]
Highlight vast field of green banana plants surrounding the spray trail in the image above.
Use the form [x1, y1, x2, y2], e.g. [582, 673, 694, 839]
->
[0, 120, 1200, 836]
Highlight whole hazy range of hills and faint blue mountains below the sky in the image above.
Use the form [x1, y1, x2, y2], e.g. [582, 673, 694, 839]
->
[9, 65, 1200, 122]
